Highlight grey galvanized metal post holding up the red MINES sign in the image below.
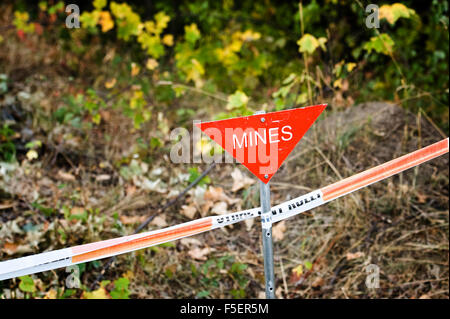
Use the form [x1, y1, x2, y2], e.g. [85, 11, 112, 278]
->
[255, 111, 275, 299]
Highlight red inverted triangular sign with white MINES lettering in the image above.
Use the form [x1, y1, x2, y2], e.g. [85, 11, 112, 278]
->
[196, 104, 327, 183]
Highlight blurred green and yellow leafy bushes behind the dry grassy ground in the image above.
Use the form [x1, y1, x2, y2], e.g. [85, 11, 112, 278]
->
[3, 0, 449, 131]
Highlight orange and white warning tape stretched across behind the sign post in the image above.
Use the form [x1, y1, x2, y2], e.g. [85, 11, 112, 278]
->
[0, 138, 449, 280]
